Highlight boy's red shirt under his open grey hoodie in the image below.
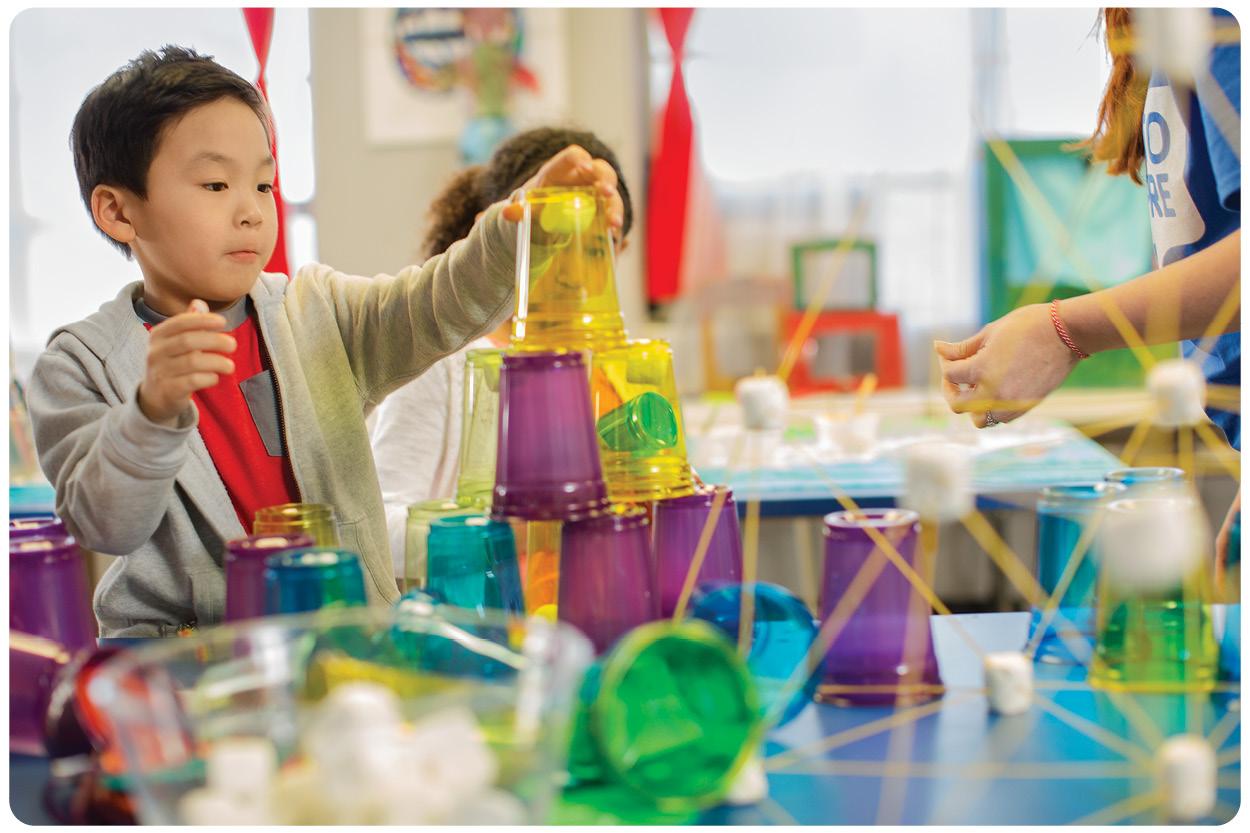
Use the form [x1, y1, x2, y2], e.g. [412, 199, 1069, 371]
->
[138, 299, 300, 534]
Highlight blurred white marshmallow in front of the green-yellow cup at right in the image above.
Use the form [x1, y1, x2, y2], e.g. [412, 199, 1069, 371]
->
[1098, 492, 1206, 593]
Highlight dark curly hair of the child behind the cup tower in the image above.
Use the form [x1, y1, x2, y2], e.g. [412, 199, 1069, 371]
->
[421, 128, 634, 258]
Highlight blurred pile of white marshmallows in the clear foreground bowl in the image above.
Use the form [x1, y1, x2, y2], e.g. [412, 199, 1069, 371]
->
[179, 683, 528, 825]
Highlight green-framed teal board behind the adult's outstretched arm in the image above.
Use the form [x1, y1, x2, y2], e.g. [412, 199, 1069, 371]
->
[981, 138, 1180, 388]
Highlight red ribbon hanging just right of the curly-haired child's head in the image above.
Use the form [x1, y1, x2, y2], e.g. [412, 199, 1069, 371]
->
[646, 9, 695, 303]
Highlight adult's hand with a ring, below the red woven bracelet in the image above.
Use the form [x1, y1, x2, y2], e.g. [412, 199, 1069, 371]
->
[934, 304, 1079, 428]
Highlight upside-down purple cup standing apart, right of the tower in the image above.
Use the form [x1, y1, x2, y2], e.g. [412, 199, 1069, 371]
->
[816, 509, 943, 705]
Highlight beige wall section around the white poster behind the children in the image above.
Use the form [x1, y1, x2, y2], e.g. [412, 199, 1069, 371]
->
[310, 9, 649, 326]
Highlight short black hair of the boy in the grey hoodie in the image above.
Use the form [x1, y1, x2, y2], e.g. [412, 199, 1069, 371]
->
[70, 46, 273, 258]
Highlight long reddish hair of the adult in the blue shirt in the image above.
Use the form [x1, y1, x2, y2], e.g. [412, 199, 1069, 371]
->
[1076, 9, 1150, 185]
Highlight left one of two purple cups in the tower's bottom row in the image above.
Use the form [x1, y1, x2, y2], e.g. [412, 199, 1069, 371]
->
[556, 507, 660, 654]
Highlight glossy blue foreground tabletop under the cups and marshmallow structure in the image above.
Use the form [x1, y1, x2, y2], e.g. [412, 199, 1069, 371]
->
[9, 613, 1240, 824]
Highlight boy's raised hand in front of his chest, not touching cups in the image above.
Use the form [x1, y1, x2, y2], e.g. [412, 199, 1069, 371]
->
[139, 299, 236, 425]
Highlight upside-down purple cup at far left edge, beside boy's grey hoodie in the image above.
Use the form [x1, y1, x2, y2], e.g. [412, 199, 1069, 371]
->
[9, 535, 99, 652]
